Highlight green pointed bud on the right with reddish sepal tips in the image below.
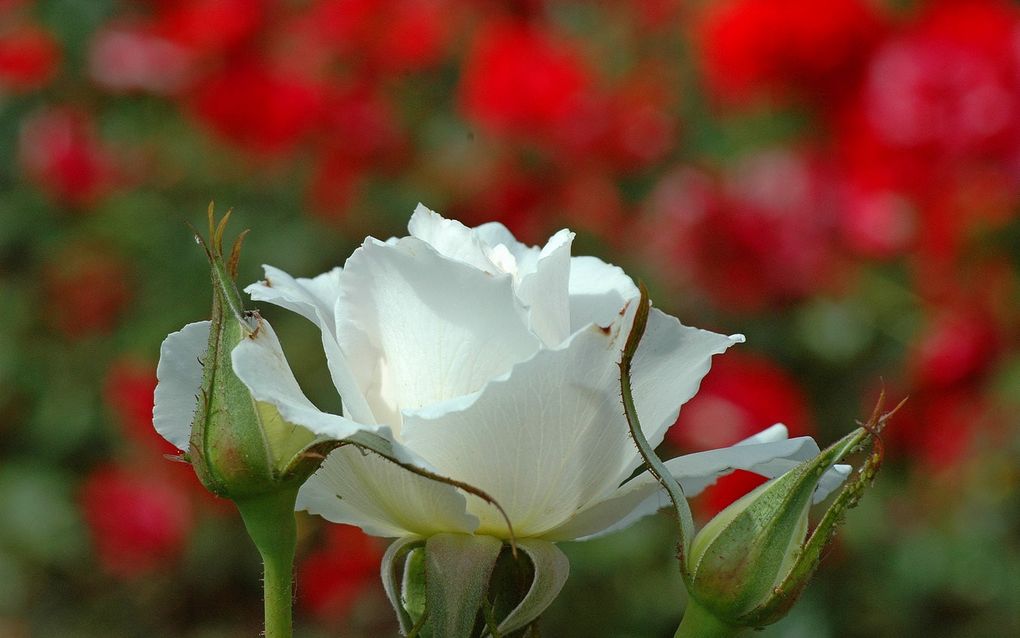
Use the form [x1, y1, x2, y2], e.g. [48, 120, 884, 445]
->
[676, 394, 896, 636]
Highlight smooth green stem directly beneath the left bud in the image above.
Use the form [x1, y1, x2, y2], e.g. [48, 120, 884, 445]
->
[235, 488, 298, 638]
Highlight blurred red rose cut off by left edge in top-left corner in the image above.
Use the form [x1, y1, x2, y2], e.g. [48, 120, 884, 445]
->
[0, 24, 60, 93]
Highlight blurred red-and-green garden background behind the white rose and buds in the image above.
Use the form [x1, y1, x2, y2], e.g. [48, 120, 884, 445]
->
[0, 0, 1020, 638]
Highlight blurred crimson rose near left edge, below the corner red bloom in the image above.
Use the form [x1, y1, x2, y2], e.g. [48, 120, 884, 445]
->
[17, 108, 115, 207]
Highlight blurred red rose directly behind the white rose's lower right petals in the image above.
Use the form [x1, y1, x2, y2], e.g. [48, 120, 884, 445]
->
[666, 351, 814, 517]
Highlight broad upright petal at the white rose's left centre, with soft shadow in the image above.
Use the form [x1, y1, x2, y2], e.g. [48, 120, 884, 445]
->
[337, 237, 540, 431]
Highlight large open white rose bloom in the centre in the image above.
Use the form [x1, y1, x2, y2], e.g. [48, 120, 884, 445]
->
[217, 206, 828, 541]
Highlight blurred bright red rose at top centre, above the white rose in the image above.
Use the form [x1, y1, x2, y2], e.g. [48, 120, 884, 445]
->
[459, 21, 592, 136]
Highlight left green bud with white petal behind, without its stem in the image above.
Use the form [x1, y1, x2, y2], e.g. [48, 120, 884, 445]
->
[154, 206, 320, 501]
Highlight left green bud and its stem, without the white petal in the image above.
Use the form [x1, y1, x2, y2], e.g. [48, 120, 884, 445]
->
[182, 204, 318, 638]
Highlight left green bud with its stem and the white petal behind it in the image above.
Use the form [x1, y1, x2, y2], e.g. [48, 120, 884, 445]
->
[153, 204, 322, 638]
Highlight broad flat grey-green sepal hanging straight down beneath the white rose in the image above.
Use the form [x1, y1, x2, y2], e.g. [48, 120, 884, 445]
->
[425, 534, 503, 638]
